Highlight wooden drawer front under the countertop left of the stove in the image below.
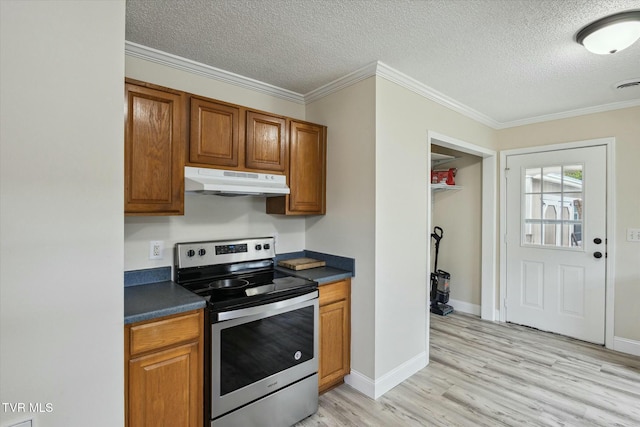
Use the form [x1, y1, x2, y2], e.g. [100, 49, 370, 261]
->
[129, 313, 201, 356]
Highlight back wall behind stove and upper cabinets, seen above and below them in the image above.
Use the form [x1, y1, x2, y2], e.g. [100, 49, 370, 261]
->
[124, 55, 305, 271]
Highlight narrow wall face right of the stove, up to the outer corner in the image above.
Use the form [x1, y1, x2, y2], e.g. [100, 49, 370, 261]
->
[306, 77, 376, 379]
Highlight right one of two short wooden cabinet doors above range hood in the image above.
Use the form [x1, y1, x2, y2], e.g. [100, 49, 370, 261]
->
[245, 111, 287, 172]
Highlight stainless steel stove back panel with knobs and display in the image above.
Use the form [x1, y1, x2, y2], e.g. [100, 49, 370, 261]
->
[174, 237, 276, 268]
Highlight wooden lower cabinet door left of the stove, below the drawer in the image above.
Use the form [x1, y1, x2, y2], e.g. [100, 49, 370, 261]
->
[128, 343, 202, 427]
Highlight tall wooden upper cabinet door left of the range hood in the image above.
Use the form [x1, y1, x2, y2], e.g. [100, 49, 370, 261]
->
[124, 83, 185, 215]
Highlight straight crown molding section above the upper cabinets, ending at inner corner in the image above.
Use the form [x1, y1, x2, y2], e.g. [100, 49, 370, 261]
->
[124, 40, 305, 104]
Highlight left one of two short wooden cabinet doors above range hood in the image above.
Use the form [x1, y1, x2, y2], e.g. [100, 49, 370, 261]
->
[189, 97, 240, 168]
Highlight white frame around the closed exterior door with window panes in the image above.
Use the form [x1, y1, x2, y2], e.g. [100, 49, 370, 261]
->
[499, 137, 616, 349]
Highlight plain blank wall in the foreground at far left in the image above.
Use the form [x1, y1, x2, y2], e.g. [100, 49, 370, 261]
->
[0, 1, 125, 427]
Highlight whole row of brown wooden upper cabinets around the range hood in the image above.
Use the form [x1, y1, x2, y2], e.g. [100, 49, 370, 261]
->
[124, 79, 327, 215]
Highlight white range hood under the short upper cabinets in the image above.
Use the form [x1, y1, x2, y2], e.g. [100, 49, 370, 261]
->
[184, 166, 289, 197]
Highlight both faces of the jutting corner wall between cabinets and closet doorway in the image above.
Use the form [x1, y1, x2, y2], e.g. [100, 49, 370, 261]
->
[306, 73, 496, 397]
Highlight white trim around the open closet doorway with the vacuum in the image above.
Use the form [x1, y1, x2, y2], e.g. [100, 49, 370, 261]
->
[427, 131, 498, 321]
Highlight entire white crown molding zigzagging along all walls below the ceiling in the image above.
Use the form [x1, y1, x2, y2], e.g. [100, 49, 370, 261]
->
[125, 41, 640, 130]
